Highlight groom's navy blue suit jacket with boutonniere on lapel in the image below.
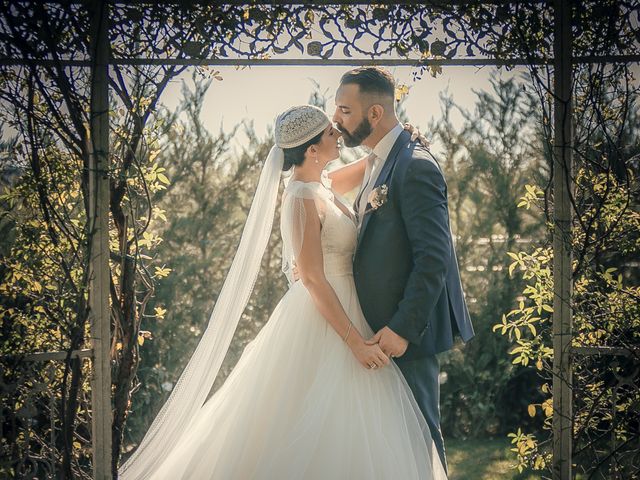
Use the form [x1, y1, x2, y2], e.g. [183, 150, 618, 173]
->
[353, 131, 474, 360]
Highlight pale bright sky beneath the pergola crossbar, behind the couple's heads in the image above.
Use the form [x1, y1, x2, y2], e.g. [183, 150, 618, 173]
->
[161, 66, 525, 154]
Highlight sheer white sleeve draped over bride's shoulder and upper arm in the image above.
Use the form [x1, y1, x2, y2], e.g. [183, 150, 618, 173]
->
[280, 181, 333, 285]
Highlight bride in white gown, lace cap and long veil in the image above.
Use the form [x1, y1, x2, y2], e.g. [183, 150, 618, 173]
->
[118, 105, 446, 480]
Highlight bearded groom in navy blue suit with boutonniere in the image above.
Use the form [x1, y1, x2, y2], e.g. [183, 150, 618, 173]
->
[333, 67, 474, 469]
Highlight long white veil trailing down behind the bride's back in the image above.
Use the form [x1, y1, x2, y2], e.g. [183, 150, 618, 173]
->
[118, 146, 284, 480]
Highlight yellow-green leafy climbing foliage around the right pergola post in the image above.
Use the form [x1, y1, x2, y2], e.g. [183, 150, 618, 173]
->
[494, 66, 640, 478]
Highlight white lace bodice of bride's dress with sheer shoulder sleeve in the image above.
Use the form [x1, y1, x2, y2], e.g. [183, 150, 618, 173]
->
[280, 180, 357, 282]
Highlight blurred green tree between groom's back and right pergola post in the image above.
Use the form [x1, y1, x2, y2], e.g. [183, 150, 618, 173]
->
[428, 78, 545, 438]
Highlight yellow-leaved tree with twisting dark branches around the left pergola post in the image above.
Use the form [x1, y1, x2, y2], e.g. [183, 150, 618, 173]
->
[0, 2, 258, 477]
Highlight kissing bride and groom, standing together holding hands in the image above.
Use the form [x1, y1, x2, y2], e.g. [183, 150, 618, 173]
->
[118, 67, 474, 480]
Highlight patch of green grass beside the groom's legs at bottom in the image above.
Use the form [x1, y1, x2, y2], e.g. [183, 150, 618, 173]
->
[445, 438, 540, 480]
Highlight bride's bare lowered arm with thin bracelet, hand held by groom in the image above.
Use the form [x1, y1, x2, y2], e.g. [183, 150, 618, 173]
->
[296, 199, 389, 368]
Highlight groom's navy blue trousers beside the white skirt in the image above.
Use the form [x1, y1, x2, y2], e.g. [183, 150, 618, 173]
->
[395, 355, 448, 471]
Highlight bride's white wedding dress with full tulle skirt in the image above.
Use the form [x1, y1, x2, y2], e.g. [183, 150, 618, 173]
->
[154, 181, 446, 480]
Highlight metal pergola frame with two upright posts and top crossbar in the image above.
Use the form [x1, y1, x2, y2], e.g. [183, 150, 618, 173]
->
[0, 0, 640, 480]
